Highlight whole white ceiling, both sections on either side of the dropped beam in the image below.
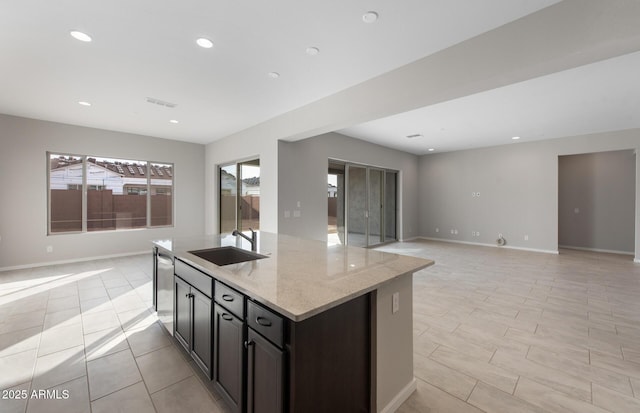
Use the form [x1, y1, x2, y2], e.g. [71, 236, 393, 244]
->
[0, 0, 564, 148]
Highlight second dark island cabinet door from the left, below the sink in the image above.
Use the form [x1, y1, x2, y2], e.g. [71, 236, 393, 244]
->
[191, 288, 213, 378]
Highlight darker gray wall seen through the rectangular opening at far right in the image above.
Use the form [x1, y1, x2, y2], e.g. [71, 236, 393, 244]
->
[558, 151, 636, 253]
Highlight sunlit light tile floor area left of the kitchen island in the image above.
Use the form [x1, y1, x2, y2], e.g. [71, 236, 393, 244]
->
[0, 254, 227, 413]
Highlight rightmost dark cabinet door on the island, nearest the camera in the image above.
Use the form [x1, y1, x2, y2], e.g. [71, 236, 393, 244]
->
[247, 329, 284, 413]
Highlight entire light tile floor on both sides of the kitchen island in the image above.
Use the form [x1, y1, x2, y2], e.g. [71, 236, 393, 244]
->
[0, 241, 640, 413]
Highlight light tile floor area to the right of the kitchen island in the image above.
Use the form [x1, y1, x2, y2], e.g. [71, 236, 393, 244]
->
[379, 241, 640, 413]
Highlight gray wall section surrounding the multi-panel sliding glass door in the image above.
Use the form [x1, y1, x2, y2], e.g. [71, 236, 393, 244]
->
[278, 133, 418, 240]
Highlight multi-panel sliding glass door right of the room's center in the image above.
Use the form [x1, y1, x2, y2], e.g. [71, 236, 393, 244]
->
[327, 160, 398, 247]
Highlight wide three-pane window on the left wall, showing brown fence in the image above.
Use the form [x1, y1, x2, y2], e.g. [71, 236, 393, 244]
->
[47, 153, 173, 234]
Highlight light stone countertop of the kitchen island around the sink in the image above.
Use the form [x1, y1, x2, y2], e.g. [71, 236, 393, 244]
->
[154, 232, 434, 321]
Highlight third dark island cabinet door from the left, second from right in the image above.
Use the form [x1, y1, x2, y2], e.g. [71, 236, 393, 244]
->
[213, 304, 244, 412]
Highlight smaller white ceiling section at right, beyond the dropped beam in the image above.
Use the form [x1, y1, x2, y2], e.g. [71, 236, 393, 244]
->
[338, 52, 640, 154]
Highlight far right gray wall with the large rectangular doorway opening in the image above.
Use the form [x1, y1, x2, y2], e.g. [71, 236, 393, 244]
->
[418, 129, 640, 258]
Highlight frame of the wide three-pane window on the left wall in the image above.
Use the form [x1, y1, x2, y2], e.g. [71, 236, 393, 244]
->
[46, 151, 176, 236]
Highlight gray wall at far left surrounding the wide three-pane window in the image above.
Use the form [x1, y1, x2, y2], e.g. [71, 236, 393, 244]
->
[0, 115, 204, 269]
